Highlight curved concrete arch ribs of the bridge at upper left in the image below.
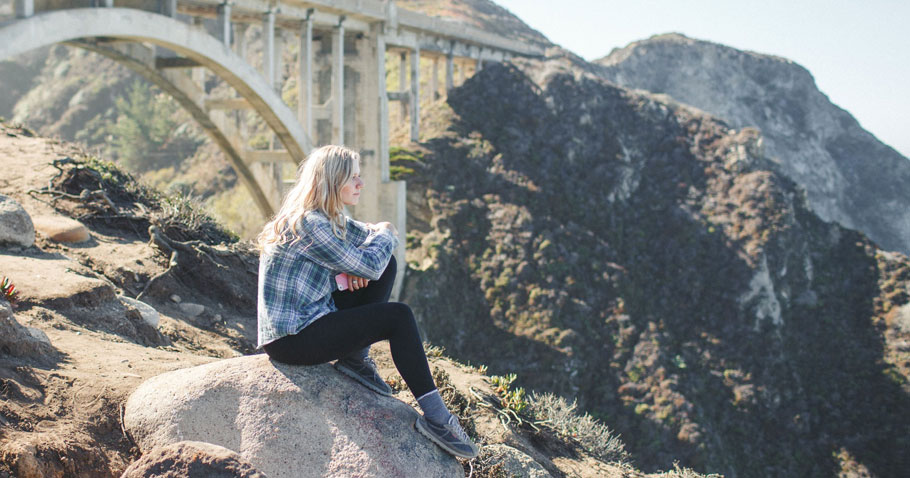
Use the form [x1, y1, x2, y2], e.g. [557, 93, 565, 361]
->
[0, 8, 312, 218]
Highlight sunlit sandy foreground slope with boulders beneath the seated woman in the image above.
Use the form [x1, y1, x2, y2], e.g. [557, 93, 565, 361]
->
[0, 119, 702, 478]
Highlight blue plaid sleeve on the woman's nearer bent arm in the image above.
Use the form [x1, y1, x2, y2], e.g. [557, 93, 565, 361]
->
[301, 213, 398, 280]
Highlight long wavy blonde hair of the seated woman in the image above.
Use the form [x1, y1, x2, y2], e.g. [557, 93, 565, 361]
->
[256, 145, 360, 250]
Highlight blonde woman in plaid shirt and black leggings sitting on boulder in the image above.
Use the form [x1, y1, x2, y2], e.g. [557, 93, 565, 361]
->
[258, 146, 477, 458]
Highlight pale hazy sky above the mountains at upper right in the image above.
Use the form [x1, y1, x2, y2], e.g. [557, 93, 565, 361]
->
[493, 0, 910, 159]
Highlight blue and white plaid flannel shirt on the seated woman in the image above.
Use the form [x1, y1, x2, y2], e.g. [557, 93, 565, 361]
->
[257, 212, 398, 347]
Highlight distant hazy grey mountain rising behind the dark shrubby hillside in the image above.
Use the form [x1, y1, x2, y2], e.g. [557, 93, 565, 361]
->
[595, 34, 910, 254]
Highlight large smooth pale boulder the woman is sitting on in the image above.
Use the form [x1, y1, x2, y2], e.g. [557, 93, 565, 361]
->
[124, 355, 464, 478]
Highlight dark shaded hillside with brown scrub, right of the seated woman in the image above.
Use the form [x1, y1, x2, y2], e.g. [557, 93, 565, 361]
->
[405, 59, 910, 477]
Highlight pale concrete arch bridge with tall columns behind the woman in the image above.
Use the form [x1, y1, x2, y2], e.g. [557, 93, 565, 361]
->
[0, 0, 543, 288]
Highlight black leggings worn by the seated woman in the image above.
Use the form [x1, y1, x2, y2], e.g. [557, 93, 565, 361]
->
[263, 256, 436, 397]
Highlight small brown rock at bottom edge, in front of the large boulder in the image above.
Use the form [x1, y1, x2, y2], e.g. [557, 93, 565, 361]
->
[120, 441, 265, 478]
